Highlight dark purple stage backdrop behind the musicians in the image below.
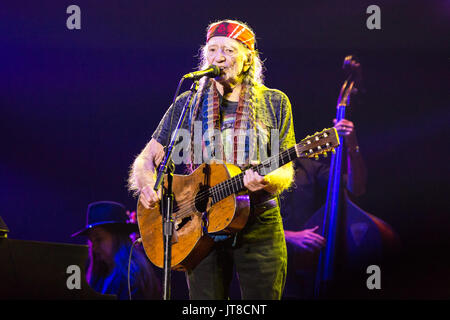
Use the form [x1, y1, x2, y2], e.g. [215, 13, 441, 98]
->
[0, 0, 450, 298]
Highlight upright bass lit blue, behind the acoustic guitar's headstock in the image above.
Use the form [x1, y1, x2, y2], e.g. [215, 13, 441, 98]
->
[305, 55, 396, 298]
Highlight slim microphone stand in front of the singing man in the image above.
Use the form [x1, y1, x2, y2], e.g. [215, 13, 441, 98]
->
[153, 79, 198, 300]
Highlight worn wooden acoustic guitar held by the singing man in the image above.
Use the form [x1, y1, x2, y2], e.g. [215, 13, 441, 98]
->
[137, 128, 339, 271]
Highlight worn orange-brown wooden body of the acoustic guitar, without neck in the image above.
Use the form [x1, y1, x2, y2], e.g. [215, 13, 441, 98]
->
[137, 163, 250, 270]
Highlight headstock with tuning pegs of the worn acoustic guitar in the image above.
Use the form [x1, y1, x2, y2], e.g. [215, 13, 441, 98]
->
[295, 128, 340, 159]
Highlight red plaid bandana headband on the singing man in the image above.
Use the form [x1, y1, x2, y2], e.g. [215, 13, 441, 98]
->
[206, 21, 255, 51]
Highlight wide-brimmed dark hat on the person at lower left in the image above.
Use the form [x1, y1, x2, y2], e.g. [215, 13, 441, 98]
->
[72, 201, 139, 237]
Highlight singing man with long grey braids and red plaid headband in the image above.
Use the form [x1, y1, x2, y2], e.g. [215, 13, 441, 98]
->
[129, 20, 295, 299]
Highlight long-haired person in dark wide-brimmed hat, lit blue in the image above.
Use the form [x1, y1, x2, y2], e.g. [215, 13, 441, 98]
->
[72, 201, 161, 300]
